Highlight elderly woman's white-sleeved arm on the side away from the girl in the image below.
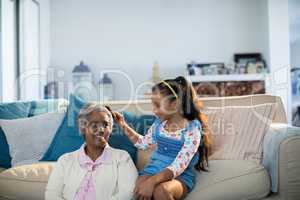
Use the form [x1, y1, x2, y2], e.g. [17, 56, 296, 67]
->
[45, 159, 64, 200]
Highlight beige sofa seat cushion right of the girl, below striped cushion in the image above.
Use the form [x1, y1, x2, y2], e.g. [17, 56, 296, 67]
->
[187, 160, 270, 200]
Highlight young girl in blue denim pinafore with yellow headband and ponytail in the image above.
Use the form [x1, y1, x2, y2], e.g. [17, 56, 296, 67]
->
[113, 77, 209, 200]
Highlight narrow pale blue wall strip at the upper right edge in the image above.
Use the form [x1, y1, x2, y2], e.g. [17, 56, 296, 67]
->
[289, 0, 300, 67]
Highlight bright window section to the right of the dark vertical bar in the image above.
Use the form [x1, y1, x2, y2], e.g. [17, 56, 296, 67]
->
[19, 0, 41, 100]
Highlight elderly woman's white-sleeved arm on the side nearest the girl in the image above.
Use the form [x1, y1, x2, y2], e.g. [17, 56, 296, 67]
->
[118, 152, 138, 200]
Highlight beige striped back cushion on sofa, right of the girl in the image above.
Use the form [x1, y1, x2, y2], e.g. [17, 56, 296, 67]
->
[205, 103, 275, 162]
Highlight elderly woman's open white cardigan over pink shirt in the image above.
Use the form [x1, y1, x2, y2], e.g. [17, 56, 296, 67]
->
[45, 147, 138, 200]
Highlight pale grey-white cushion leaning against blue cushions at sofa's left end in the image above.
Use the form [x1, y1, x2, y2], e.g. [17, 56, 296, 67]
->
[0, 113, 65, 167]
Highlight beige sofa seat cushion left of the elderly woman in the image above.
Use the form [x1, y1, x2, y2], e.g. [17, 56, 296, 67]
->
[0, 162, 54, 200]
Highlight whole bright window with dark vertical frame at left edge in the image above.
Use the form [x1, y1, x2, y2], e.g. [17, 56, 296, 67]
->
[0, 0, 42, 102]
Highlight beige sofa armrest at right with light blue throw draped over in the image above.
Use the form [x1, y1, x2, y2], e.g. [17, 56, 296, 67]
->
[262, 124, 300, 200]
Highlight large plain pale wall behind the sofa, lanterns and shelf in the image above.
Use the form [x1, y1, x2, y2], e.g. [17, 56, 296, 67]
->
[50, 0, 268, 99]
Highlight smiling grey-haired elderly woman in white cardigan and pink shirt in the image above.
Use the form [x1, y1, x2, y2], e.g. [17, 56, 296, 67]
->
[45, 104, 137, 200]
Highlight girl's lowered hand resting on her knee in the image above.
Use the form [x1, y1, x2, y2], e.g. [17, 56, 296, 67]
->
[133, 177, 155, 200]
